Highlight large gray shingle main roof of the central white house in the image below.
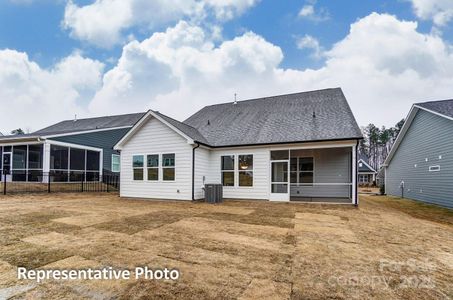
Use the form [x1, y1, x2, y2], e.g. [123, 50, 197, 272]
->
[184, 88, 362, 147]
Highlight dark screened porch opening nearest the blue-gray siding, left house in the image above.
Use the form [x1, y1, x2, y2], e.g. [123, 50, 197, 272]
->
[50, 145, 101, 182]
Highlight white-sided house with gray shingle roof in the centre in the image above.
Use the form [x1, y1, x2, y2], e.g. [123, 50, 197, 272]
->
[114, 88, 362, 204]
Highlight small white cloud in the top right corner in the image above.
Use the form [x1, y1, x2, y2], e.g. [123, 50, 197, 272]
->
[408, 0, 453, 26]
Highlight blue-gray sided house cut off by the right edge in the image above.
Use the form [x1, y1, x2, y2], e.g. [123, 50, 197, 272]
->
[384, 100, 453, 208]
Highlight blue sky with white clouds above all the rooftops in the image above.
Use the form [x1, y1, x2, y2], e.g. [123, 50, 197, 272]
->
[0, 0, 453, 132]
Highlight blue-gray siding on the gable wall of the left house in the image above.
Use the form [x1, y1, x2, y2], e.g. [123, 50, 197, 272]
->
[51, 128, 129, 171]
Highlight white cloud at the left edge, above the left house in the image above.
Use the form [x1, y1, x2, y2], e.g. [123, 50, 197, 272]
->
[0, 49, 104, 134]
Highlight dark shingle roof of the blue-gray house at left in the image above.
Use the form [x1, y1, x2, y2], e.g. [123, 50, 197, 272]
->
[33, 113, 145, 135]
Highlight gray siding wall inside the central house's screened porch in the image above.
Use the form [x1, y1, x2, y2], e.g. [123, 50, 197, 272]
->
[291, 148, 352, 198]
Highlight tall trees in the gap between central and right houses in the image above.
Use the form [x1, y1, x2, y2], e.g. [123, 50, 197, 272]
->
[359, 119, 404, 171]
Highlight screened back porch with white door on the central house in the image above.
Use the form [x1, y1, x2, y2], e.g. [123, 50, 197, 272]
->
[270, 143, 358, 204]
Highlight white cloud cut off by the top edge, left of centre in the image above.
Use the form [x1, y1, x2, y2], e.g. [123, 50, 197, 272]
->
[63, 0, 259, 48]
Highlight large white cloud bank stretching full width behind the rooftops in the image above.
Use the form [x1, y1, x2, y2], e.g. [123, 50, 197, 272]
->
[0, 13, 453, 131]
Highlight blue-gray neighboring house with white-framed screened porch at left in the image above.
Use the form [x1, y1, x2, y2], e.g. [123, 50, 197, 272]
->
[0, 113, 145, 182]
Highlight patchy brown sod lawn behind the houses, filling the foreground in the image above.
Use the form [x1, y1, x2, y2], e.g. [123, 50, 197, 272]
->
[0, 194, 453, 299]
